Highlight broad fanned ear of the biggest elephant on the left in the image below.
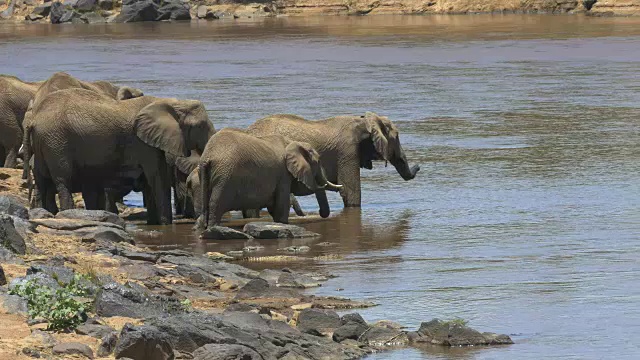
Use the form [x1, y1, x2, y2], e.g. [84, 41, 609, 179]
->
[133, 102, 189, 156]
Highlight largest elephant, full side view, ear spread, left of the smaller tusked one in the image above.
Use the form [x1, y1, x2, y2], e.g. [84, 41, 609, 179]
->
[25, 89, 215, 224]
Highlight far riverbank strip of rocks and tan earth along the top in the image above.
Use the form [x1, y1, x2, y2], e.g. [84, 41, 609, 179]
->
[0, 0, 640, 24]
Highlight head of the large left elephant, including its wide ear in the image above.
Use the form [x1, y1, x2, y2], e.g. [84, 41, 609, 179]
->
[134, 99, 215, 156]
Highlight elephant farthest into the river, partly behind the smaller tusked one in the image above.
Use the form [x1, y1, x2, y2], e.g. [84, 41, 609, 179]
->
[247, 112, 420, 211]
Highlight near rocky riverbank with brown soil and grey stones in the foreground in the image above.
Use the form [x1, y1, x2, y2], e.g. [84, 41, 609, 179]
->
[0, 169, 512, 360]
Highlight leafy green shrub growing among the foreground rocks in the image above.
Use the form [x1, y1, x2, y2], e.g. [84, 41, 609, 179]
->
[9, 275, 90, 330]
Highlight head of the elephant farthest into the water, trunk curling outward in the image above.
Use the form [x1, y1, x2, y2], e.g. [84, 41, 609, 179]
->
[359, 112, 420, 180]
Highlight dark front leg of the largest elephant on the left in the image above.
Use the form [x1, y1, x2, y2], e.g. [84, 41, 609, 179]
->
[142, 149, 173, 225]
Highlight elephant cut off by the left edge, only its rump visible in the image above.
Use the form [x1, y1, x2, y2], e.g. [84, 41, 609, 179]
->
[0, 75, 42, 168]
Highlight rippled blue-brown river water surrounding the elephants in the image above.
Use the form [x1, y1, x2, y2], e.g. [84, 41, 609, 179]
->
[0, 15, 640, 360]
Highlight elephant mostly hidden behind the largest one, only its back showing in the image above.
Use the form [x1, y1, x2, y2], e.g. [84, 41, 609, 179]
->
[22, 72, 144, 179]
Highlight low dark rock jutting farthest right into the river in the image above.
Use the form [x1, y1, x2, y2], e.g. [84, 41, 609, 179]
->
[413, 319, 513, 346]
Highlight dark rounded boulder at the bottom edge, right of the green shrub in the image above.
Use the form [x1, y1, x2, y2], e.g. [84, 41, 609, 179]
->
[114, 324, 174, 360]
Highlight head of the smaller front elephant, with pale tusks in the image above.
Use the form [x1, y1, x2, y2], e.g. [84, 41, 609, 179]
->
[285, 141, 342, 191]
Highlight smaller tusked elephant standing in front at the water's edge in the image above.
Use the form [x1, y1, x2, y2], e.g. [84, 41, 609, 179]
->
[199, 129, 341, 227]
